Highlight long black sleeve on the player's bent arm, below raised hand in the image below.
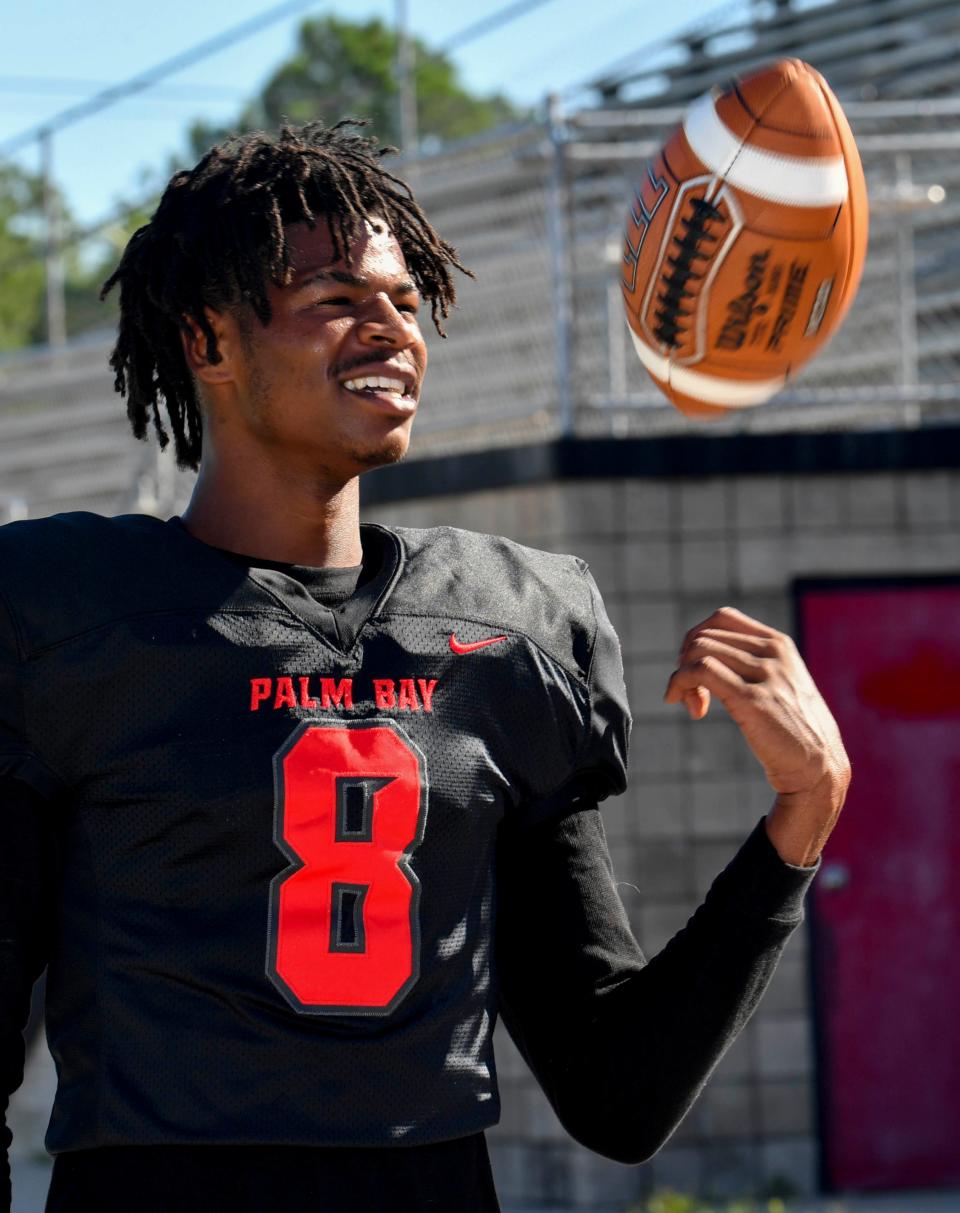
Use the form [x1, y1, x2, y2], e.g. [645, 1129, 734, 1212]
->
[498, 808, 819, 1162]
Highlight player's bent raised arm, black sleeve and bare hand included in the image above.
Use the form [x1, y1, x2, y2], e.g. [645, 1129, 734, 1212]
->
[498, 608, 850, 1162]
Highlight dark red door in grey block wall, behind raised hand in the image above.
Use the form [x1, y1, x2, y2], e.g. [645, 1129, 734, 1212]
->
[799, 582, 960, 1190]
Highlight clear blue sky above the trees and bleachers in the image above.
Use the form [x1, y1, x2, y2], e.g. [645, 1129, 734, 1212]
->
[0, 0, 720, 224]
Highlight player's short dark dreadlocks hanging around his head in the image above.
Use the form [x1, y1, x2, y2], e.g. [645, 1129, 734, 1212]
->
[101, 119, 470, 468]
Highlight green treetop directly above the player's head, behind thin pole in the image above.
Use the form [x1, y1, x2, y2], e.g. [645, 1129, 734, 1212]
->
[191, 16, 527, 155]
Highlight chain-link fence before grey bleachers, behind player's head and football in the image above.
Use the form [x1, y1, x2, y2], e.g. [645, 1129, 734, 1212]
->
[0, 99, 960, 516]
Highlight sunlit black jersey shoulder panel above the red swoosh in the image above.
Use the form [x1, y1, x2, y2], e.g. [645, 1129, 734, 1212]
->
[388, 526, 598, 679]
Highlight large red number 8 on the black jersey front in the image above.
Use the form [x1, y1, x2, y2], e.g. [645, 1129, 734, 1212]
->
[267, 721, 427, 1015]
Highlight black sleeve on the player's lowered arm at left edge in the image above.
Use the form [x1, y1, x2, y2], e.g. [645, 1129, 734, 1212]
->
[0, 778, 58, 1213]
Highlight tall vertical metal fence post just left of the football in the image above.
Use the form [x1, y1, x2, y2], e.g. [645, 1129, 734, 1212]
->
[547, 93, 573, 437]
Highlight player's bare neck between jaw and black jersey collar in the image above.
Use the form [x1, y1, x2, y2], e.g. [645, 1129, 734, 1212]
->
[182, 451, 363, 568]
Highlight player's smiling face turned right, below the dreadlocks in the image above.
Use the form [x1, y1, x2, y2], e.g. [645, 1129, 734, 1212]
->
[194, 220, 427, 483]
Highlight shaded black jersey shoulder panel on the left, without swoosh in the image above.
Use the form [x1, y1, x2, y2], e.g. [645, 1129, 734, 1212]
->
[0, 512, 243, 651]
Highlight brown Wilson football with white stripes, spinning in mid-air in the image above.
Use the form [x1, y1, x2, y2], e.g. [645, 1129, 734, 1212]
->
[621, 59, 868, 416]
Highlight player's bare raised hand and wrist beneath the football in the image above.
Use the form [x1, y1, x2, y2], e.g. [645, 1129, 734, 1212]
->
[664, 607, 851, 864]
